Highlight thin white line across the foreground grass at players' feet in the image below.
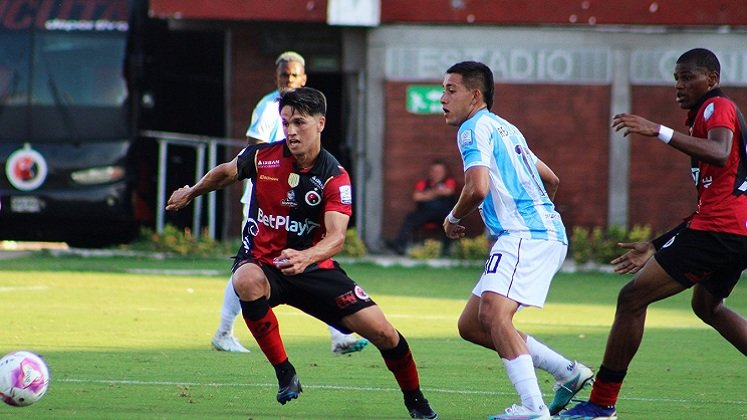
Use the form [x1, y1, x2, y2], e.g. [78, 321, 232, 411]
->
[59, 378, 747, 405]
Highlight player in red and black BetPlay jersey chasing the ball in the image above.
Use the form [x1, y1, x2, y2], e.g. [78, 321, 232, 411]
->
[166, 87, 438, 419]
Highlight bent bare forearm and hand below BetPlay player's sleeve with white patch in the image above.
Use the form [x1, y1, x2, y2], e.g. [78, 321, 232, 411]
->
[280, 211, 350, 276]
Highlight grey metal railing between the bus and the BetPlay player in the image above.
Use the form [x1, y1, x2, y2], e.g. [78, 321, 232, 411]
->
[140, 130, 246, 239]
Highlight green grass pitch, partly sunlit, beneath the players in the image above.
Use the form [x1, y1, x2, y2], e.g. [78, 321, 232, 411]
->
[0, 251, 747, 420]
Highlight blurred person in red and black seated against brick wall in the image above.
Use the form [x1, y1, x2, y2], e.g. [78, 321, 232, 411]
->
[386, 160, 457, 255]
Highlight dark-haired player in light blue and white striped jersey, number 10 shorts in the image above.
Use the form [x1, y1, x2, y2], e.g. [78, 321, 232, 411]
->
[441, 61, 593, 420]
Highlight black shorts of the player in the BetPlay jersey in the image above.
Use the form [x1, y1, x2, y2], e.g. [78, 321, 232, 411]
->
[231, 259, 376, 334]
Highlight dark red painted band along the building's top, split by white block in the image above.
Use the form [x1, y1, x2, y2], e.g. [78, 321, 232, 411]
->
[150, 0, 747, 25]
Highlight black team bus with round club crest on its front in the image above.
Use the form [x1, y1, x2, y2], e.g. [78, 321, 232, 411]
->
[0, 0, 136, 243]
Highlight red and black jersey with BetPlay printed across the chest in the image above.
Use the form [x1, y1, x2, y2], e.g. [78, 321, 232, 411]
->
[237, 140, 353, 270]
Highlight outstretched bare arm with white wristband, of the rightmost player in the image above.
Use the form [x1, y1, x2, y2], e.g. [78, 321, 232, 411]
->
[612, 114, 734, 167]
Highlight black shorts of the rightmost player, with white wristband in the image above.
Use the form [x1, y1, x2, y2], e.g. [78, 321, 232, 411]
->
[654, 229, 747, 299]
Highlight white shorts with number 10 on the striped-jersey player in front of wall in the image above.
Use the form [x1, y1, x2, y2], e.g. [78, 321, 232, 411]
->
[472, 235, 568, 308]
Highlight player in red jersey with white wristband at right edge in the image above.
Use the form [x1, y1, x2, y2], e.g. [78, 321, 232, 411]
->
[561, 48, 747, 419]
